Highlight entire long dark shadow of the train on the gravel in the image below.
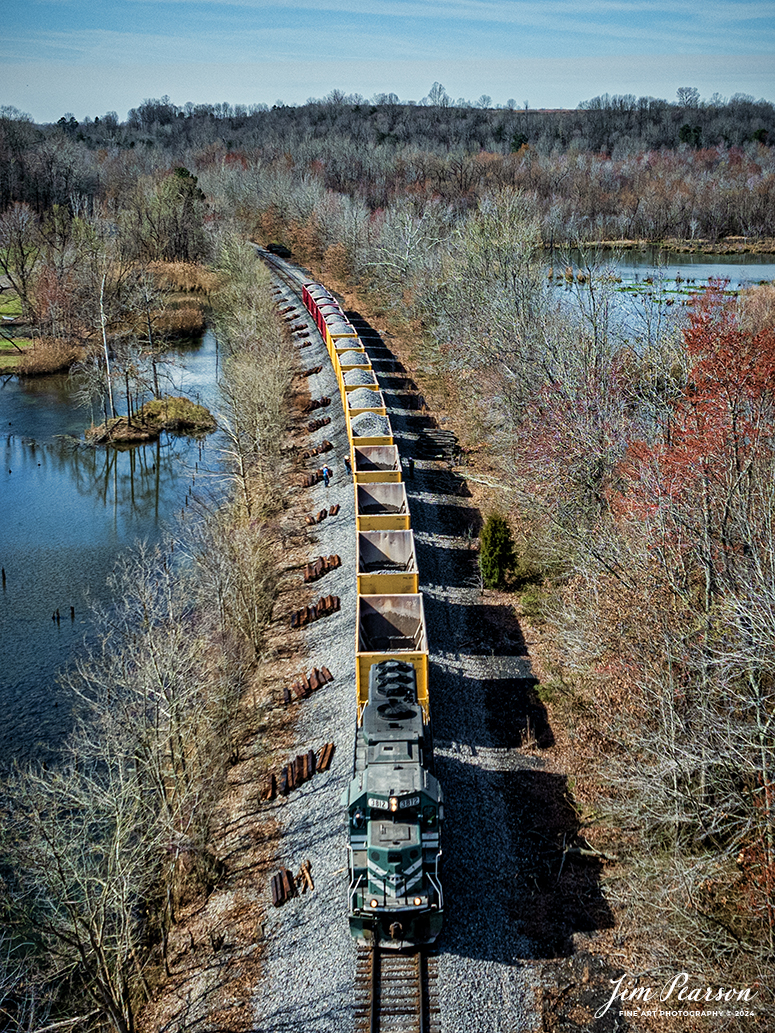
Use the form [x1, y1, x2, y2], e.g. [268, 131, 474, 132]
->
[347, 301, 614, 965]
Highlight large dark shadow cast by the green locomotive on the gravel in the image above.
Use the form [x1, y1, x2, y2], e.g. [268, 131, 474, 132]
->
[436, 755, 614, 964]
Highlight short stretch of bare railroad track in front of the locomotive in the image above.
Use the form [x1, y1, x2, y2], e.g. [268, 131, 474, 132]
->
[355, 946, 441, 1033]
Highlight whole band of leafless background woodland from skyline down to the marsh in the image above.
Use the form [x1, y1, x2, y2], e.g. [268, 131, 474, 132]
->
[0, 84, 775, 246]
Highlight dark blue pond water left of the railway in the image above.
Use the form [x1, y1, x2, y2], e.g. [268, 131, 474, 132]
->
[0, 334, 223, 765]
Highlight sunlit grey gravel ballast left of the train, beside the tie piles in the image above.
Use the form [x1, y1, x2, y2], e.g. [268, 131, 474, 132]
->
[254, 283, 355, 1033]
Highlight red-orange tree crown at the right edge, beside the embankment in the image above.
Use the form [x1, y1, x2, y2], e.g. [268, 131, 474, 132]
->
[615, 283, 775, 609]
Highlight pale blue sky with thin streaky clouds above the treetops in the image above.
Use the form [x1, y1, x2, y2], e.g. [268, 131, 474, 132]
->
[0, 0, 775, 122]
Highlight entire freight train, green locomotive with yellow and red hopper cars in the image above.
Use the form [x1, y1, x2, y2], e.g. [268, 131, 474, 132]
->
[302, 282, 443, 949]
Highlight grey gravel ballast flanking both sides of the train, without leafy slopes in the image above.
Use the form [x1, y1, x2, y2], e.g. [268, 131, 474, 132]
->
[254, 274, 546, 1033]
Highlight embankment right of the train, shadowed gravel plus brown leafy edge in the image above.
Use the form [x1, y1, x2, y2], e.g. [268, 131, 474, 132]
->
[301, 274, 632, 1033]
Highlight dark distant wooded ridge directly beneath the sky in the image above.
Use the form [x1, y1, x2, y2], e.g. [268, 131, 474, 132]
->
[37, 83, 775, 155]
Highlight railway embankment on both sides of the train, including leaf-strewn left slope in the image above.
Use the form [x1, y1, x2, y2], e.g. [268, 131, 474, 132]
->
[138, 260, 624, 1033]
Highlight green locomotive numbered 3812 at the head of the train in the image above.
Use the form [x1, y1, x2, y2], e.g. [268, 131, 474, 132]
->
[342, 659, 443, 949]
